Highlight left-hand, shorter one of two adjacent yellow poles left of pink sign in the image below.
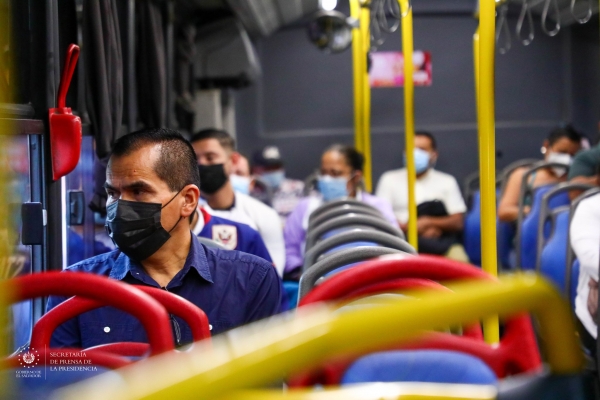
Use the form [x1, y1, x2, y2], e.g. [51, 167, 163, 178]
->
[350, 0, 363, 152]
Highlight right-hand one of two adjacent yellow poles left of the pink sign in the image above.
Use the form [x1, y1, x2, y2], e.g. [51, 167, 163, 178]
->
[360, 4, 373, 192]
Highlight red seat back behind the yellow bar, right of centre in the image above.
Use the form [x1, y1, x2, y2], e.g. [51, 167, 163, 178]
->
[289, 256, 541, 387]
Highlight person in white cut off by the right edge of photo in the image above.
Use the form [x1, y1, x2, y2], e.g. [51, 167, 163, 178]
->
[570, 169, 600, 358]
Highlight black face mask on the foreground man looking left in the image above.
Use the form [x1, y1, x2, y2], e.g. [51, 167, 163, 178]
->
[105, 192, 181, 262]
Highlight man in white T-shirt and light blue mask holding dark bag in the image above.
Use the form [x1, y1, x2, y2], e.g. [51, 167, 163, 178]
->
[376, 132, 468, 261]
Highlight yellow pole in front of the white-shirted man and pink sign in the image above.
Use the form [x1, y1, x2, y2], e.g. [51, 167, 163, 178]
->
[398, 0, 419, 250]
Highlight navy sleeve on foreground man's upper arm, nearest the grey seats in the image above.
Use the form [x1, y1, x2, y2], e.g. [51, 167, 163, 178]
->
[244, 263, 283, 323]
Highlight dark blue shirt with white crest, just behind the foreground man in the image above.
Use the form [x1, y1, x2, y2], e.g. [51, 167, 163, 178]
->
[198, 208, 273, 263]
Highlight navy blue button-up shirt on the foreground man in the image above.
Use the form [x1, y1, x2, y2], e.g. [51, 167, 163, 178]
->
[47, 235, 282, 348]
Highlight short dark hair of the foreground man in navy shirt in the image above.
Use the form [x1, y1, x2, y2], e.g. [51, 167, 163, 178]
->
[111, 128, 200, 192]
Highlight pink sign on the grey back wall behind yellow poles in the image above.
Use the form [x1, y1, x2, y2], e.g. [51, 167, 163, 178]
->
[369, 50, 432, 87]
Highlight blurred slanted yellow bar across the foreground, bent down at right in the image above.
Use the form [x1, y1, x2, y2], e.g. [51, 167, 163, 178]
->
[56, 273, 584, 400]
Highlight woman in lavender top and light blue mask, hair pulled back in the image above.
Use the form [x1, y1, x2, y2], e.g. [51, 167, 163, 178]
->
[283, 144, 396, 279]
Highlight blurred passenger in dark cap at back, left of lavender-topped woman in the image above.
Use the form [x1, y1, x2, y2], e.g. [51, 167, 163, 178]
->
[251, 146, 304, 226]
